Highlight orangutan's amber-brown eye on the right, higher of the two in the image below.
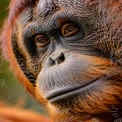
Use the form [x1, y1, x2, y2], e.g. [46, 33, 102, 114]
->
[61, 23, 79, 37]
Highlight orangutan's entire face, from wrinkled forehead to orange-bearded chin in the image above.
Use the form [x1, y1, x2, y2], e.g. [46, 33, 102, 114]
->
[9, 0, 122, 122]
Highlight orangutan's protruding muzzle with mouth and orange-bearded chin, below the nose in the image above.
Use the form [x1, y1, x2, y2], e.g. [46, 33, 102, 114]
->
[36, 54, 122, 117]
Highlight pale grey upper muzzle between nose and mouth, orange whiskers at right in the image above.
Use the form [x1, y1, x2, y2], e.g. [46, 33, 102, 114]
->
[36, 55, 109, 98]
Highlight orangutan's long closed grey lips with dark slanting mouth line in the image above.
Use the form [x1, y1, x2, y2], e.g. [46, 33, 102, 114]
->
[45, 78, 101, 103]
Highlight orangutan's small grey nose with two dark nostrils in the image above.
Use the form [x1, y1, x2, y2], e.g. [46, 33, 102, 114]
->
[48, 51, 65, 66]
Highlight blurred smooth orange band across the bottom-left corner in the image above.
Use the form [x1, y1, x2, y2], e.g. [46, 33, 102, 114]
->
[0, 106, 53, 122]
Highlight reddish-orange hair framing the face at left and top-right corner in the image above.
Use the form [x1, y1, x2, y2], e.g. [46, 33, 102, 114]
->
[0, 0, 122, 95]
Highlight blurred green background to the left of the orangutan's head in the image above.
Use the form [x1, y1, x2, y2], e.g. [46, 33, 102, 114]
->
[0, 0, 45, 114]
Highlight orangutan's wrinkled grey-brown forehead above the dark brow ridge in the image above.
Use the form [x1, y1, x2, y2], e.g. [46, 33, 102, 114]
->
[19, 0, 97, 30]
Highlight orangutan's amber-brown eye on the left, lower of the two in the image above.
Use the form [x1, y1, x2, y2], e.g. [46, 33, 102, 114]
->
[34, 34, 50, 47]
